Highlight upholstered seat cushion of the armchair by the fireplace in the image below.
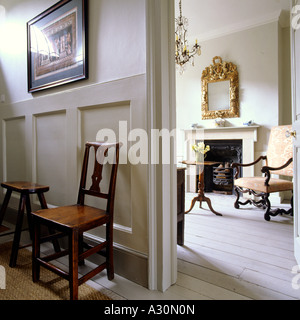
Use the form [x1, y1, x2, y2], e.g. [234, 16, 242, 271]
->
[234, 177, 293, 193]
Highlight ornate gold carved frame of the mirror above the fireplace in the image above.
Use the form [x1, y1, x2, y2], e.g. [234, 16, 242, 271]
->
[201, 57, 240, 120]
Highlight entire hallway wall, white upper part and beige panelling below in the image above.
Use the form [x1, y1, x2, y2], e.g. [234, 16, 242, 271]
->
[0, 0, 148, 285]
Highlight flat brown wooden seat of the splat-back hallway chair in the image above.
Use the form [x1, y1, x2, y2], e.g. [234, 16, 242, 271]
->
[32, 204, 109, 232]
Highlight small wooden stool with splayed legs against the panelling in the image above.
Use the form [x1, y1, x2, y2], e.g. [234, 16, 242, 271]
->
[0, 181, 49, 268]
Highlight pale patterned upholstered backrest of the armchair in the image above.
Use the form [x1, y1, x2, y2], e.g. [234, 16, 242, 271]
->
[267, 125, 293, 176]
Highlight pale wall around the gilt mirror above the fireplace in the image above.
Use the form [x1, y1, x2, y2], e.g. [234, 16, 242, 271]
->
[176, 22, 291, 160]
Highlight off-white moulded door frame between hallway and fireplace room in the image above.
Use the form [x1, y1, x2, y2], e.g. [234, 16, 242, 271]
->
[146, 0, 177, 291]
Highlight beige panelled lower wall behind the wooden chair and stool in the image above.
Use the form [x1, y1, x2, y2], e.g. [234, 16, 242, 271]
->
[1, 75, 148, 284]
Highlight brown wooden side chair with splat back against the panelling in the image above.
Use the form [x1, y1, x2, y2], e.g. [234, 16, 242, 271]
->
[32, 142, 120, 300]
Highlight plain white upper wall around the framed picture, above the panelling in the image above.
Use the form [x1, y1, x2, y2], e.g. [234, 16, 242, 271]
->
[0, 0, 146, 103]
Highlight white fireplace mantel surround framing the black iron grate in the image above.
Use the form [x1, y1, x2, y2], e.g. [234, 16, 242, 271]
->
[184, 125, 259, 192]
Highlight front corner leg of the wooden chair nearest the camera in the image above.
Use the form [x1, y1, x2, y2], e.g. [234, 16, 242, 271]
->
[69, 230, 79, 300]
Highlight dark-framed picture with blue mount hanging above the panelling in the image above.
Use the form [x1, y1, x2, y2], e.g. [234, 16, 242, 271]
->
[27, 0, 88, 92]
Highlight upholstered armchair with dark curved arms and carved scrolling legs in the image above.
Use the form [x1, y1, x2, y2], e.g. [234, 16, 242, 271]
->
[232, 125, 293, 221]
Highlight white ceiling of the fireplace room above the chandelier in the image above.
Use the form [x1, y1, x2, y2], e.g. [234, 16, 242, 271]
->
[175, 0, 291, 41]
